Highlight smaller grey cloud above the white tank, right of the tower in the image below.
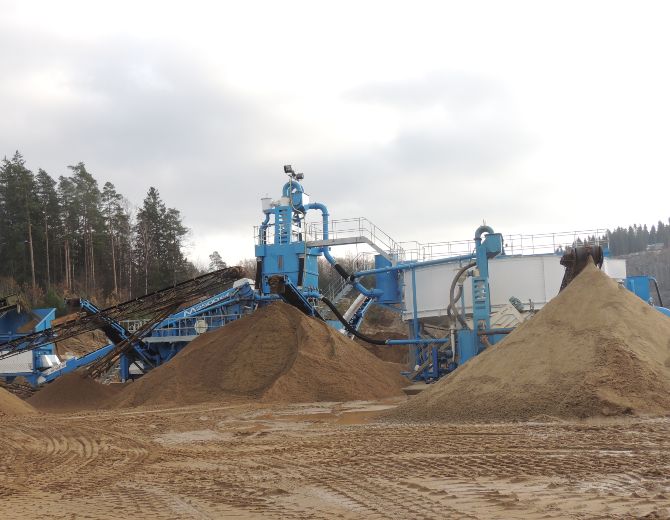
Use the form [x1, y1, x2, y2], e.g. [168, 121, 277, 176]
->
[347, 72, 532, 176]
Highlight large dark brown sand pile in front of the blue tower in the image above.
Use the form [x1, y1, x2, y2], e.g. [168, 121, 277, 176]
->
[111, 302, 407, 407]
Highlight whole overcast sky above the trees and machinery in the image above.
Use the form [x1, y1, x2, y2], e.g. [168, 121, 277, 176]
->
[0, 0, 670, 264]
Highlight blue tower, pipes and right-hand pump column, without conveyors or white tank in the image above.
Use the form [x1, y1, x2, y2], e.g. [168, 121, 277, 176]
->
[256, 166, 508, 379]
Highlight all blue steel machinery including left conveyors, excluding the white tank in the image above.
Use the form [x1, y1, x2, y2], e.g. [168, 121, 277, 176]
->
[0, 166, 668, 384]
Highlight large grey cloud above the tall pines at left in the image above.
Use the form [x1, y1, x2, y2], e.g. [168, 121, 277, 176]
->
[0, 25, 281, 235]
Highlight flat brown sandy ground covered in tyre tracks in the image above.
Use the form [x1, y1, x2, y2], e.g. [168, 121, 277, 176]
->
[0, 402, 670, 519]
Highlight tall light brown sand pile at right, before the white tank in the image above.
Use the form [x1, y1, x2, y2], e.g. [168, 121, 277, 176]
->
[386, 265, 670, 422]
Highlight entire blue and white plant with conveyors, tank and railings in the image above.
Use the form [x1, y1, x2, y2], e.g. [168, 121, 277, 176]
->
[0, 166, 660, 385]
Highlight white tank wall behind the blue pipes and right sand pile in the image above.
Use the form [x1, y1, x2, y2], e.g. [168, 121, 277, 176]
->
[402, 254, 626, 320]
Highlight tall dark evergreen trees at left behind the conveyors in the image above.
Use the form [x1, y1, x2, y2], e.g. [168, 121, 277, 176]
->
[0, 152, 197, 306]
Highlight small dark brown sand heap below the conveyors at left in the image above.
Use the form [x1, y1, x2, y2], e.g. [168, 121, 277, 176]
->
[28, 372, 122, 413]
